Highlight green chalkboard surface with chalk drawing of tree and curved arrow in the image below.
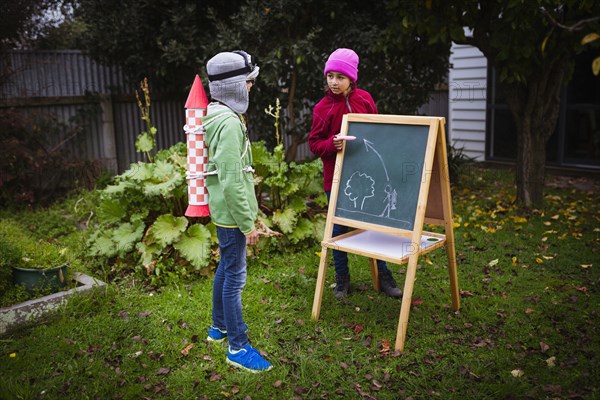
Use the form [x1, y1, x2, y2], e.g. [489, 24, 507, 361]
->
[334, 121, 430, 231]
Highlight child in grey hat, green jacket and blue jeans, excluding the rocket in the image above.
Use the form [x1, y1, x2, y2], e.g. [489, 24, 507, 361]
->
[202, 51, 273, 372]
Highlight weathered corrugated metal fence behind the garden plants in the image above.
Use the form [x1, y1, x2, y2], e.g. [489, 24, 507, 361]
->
[0, 50, 448, 173]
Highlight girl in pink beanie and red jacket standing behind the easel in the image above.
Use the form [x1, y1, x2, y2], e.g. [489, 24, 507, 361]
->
[308, 48, 402, 298]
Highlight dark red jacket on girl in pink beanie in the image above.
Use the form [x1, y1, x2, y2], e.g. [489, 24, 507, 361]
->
[308, 88, 377, 191]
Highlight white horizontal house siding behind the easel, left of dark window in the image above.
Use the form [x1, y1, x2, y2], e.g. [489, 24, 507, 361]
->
[448, 44, 487, 160]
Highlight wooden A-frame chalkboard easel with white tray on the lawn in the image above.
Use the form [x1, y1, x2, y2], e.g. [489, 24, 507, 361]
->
[312, 114, 460, 350]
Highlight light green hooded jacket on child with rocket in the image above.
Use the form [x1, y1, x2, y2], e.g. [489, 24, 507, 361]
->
[202, 103, 258, 234]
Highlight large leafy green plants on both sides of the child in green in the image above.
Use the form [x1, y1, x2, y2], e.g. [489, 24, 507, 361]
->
[88, 86, 327, 285]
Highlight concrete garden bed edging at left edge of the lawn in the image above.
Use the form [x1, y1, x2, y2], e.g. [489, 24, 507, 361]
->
[0, 272, 105, 335]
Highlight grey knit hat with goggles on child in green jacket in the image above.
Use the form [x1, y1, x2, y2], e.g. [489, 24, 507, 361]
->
[206, 50, 260, 114]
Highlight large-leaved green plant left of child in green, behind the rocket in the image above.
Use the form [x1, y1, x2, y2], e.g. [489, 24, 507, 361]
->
[88, 81, 213, 284]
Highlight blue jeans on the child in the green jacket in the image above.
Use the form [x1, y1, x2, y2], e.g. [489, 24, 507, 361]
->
[212, 226, 248, 350]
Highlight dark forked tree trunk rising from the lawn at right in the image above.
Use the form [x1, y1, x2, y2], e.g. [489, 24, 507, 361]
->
[500, 58, 568, 208]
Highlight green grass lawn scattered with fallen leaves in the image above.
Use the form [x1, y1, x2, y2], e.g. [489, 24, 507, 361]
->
[0, 167, 600, 399]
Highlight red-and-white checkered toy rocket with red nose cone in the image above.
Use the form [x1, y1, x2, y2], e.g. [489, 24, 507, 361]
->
[183, 75, 210, 217]
